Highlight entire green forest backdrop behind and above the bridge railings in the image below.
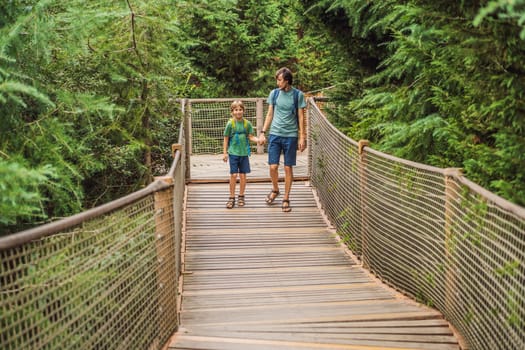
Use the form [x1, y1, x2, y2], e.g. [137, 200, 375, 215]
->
[0, 0, 525, 235]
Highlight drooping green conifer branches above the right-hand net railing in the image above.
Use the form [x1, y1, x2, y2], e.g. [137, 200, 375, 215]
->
[302, 0, 525, 205]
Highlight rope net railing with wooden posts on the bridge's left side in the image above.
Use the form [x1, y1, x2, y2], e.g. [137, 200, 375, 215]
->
[0, 125, 185, 350]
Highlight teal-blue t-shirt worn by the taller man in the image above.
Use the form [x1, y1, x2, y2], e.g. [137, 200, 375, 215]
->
[266, 89, 306, 137]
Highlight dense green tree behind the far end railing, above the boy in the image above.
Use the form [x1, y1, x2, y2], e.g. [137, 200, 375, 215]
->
[176, 0, 297, 97]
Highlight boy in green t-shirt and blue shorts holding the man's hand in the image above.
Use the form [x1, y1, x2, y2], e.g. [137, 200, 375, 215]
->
[222, 101, 259, 209]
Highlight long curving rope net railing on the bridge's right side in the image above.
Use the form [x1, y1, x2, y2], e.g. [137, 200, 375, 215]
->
[308, 99, 525, 350]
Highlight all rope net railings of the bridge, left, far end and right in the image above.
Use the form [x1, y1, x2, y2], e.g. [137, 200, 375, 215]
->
[0, 99, 525, 350]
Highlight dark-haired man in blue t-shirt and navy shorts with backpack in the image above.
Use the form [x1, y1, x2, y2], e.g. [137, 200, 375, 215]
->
[259, 67, 306, 213]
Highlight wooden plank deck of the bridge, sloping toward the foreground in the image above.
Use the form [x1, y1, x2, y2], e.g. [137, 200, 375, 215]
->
[169, 183, 459, 350]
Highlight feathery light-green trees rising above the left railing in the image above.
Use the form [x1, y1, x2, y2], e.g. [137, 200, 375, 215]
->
[0, 0, 192, 232]
